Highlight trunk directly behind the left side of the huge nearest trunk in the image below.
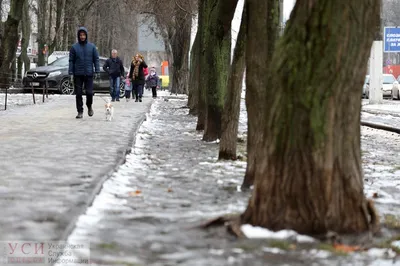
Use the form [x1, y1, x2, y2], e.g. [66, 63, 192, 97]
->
[242, 0, 280, 189]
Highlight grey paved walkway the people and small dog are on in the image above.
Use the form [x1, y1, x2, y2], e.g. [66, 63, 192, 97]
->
[0, 95, 153, 243]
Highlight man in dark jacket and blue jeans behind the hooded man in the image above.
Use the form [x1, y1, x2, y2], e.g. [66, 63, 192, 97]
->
[103, 49, 125, 102]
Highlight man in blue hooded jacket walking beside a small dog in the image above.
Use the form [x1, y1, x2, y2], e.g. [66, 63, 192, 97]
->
[68, 27, 100, 119]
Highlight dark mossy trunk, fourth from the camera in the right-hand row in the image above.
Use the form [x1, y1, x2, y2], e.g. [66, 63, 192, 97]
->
[202, 0, 237, 141]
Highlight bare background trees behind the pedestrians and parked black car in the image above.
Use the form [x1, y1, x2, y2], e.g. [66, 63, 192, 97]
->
[0, 0, 197, 93]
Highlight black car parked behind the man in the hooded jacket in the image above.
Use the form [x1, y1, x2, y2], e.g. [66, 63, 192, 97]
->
[22, 56, 127, 98]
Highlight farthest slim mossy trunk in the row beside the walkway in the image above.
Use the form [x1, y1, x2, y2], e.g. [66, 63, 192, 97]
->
[188, 32, 200, 115]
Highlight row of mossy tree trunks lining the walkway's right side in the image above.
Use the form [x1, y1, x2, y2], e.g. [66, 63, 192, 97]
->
[188, 0, 380, 234]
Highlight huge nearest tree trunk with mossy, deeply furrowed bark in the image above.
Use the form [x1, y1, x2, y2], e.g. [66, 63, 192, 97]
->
[242, 0, 380, 234]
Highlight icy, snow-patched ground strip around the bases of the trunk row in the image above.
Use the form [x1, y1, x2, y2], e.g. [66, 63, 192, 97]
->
[59, 99, 399, 266]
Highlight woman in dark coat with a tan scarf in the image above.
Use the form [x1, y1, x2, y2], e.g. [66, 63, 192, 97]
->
[129, 54, 147, 102]
